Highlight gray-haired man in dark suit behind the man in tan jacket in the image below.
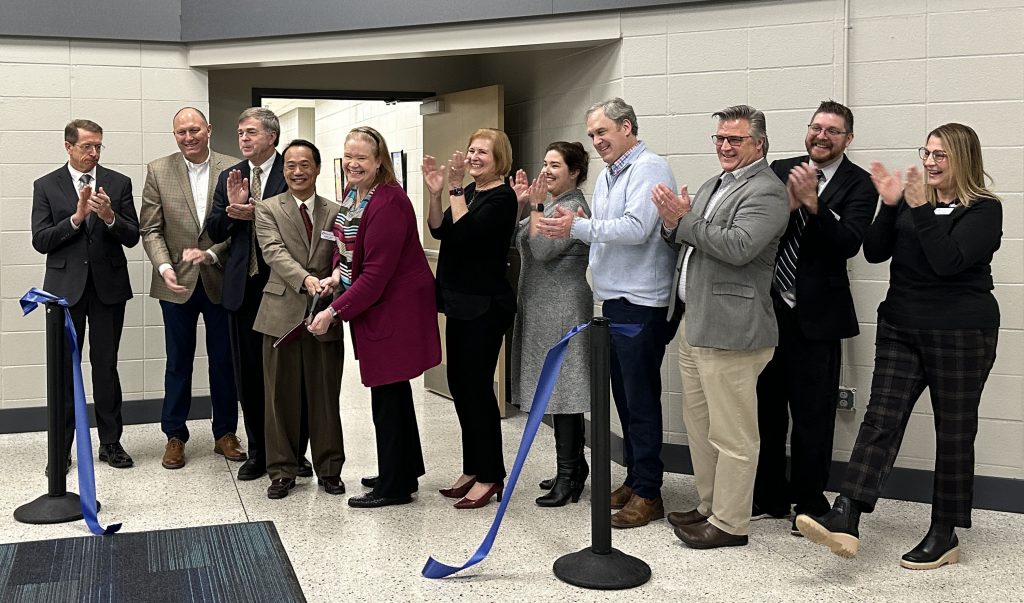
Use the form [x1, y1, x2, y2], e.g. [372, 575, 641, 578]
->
[206, 106, 312, 480]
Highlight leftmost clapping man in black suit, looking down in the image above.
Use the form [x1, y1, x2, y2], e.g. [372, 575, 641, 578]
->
[32, 120, 138, 471]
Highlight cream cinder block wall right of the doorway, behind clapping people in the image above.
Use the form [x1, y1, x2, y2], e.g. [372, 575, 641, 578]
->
[491, 0, 1024, 479]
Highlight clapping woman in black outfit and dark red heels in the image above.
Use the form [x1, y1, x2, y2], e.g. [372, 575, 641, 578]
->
[423, 128, 519, 509]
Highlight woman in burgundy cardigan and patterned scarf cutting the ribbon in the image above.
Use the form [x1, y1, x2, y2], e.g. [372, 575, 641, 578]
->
[309, 127, 441, 508]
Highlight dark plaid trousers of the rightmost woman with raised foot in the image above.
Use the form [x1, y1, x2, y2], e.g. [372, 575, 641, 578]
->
[840, 317, 998, 527]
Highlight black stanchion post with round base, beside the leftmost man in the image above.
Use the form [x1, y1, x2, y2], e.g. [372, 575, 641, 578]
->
[14, 302, 86, 523]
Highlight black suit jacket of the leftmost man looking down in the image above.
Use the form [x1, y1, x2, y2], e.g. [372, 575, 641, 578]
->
[32, 164, 138, 305]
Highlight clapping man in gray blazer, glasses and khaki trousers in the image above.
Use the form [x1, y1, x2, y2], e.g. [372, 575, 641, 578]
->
[652, 104, 790, 549]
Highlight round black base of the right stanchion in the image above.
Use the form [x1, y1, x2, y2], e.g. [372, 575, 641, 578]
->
[552, 547, 650, 591]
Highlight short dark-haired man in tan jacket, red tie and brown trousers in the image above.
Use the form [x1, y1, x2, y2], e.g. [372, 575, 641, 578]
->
[253, 139, 345, 499]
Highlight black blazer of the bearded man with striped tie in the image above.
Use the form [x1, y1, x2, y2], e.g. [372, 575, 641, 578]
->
[771, 155, 879, 341]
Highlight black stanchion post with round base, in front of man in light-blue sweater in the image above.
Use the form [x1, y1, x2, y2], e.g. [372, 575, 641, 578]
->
[553, 316, 650, 591]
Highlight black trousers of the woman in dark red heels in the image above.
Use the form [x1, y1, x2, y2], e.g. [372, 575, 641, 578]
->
[444, 303, 513, 483]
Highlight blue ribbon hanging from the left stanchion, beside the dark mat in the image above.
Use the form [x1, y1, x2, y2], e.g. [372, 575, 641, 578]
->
[20, 287, 121, 536]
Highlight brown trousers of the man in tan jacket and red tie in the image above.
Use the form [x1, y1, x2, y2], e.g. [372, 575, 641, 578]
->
[263, 333, 345, 479]
